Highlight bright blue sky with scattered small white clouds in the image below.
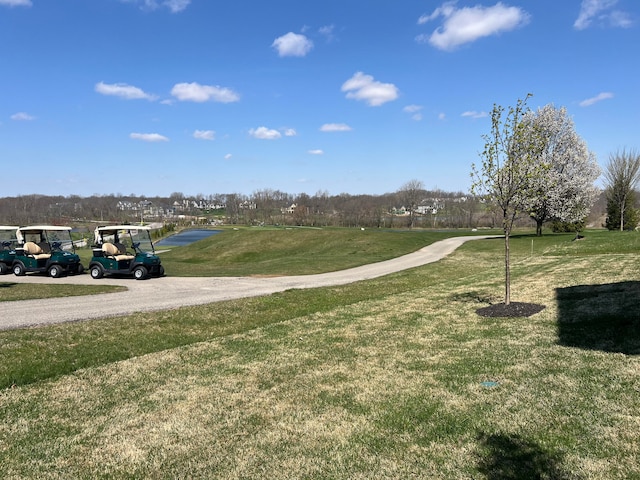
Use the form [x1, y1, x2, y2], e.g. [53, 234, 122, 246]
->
[0, 0, 640, 196]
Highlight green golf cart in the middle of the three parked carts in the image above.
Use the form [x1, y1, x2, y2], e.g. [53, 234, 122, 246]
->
[11, 225, 84, 278]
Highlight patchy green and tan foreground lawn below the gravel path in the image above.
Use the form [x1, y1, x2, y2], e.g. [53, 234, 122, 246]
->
[0, 232, 640, 479]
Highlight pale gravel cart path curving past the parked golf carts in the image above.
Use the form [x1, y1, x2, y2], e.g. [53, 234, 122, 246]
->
[0, 235, 495, 330]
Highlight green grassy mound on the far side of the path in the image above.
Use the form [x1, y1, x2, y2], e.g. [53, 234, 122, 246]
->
[160, 227, 471, 276]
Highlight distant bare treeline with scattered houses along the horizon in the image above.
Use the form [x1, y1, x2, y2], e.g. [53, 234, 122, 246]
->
[0, 189, 606, 232]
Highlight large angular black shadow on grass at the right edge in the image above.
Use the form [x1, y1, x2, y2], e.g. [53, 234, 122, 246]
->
[556, 281, 640, 355]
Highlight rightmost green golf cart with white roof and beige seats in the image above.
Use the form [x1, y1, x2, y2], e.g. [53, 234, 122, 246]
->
[89, 225, 164, 280]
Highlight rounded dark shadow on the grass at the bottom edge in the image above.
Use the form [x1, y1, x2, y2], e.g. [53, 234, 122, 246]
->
[478, 433, 579, 480]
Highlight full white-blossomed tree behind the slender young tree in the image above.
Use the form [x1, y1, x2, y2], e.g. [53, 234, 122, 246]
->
[524, 105, 600, 236]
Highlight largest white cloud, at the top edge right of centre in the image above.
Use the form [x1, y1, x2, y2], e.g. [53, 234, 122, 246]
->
[416, 1, 530, 50]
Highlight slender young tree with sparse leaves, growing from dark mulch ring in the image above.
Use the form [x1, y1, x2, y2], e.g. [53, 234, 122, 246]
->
[471, 94, 545, 305]
